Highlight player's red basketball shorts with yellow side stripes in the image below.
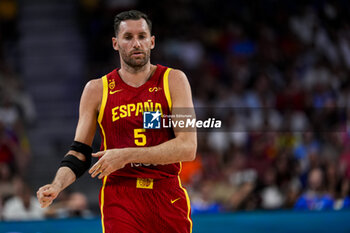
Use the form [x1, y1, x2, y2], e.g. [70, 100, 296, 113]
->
[100, 177, 192, 233]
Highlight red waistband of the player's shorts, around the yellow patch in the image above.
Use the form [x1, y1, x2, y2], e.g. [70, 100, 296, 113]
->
[106, 176, 179, 189]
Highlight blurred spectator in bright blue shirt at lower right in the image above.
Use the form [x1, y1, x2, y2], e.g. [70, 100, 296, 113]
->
[294, 168, 334, 210]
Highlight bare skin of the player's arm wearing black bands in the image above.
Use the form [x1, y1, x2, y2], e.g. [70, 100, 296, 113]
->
[37, 79, 103, 208]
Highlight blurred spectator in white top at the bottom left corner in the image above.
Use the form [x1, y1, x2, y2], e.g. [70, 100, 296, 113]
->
[2, 178, 44, 221]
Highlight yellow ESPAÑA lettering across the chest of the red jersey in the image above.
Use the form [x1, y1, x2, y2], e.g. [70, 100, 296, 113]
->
[112, 100, 163, 122]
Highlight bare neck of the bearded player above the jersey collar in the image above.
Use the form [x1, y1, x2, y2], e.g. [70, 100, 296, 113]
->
[118, 63, 156, 87]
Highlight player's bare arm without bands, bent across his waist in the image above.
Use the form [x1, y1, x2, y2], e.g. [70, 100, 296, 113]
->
[89, 70, 197, 179]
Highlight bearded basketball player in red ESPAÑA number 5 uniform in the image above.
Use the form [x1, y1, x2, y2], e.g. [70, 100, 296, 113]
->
[37, 10, 197, 233]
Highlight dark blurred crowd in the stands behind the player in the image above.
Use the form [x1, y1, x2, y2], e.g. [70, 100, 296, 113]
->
[0, 0, 350, 220]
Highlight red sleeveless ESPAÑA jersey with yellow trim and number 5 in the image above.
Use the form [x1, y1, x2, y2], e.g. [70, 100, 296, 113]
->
[98, 65, 180, 179]
